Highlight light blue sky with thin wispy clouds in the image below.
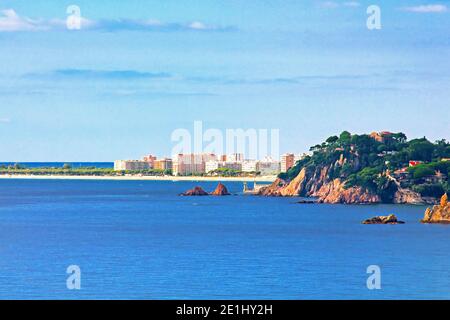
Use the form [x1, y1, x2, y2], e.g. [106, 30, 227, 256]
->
[0, 0, 450, 162]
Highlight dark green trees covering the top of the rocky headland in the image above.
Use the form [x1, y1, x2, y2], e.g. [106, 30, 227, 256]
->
[279, 131, 450, 199]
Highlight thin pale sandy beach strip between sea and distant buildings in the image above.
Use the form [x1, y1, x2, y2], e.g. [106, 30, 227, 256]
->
[0, 174, 276, 183]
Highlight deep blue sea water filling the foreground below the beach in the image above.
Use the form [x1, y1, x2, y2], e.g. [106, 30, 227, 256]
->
[0, 180, 450, 299]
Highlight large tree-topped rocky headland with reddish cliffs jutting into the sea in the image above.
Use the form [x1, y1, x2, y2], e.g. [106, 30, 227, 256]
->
[258, 132, 450, 204]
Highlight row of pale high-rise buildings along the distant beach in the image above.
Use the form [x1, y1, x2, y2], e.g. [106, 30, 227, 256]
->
[114, 153, 306, 176]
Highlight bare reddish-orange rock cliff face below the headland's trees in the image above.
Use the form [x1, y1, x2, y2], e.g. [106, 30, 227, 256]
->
[259, 167, 381, 204]
